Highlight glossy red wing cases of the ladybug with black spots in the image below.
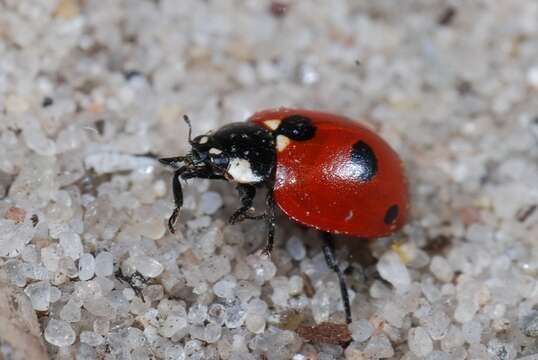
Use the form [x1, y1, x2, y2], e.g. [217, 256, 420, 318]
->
[248, 108, 409, 238]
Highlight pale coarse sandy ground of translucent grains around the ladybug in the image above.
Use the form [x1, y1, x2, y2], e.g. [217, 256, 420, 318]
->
[0, 0, 538, 360]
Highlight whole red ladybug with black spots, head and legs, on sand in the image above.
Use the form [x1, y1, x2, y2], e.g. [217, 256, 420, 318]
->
[160, 108, 408, 323]
